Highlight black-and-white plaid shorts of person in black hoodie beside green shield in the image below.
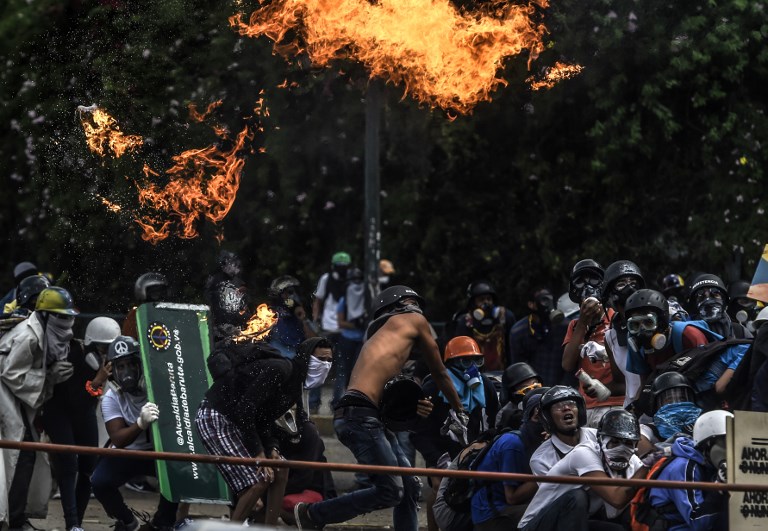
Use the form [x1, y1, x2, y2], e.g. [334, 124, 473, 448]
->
[195, 400, 260, 494]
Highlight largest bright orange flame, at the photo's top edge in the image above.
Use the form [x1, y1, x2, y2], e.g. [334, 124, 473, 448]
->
[229, 0, 548, 113]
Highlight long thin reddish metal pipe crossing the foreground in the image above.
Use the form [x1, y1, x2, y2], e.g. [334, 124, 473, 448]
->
[0, 439, 768, 492]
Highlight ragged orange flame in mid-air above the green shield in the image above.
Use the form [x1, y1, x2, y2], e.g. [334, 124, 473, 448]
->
[136, 126, 253, 244]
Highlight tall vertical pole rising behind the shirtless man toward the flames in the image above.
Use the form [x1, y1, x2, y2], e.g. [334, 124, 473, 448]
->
[364, 79, 382, 307]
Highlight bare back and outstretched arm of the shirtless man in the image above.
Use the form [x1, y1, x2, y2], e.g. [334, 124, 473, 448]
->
[349, 312, 461, 410]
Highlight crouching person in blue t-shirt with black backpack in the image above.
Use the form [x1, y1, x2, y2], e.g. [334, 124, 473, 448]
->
[472, 387, 549, 531]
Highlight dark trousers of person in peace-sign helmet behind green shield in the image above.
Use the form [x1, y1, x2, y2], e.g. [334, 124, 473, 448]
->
[91, 456, 179, 527]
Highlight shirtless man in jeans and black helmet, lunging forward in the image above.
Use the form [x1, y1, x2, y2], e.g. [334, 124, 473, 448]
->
[294, 286, 466, 531]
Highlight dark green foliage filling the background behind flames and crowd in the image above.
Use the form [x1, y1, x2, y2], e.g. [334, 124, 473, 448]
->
[0, 0, 768, 319]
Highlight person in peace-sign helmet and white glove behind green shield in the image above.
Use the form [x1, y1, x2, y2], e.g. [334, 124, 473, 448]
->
[91, 336, 178, 531]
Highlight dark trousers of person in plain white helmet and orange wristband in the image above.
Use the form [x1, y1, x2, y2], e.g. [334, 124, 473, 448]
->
[43, 404, 99, 529]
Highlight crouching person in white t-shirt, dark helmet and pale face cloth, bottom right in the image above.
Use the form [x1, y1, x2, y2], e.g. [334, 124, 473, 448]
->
[518, 409, 648, 531]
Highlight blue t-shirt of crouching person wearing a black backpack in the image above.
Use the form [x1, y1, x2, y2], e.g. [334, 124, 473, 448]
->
[472, 433, 531, 524]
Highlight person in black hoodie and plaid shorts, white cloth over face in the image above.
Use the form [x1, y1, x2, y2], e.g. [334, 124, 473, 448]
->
[195, 337, 333, 525]
